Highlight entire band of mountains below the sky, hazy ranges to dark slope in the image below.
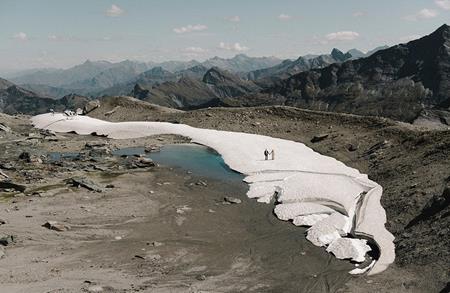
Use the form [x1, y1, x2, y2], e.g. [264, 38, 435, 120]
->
[0, 25, 450, 124]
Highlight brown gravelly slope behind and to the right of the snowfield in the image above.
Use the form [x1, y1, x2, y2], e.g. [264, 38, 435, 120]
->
[85, 97, 450, 292]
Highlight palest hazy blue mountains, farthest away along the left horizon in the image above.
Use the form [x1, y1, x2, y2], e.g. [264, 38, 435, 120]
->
[7, 54, 281, 97]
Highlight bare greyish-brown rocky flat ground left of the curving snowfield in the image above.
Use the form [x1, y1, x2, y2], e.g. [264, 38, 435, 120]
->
[0, 110, 352, 292]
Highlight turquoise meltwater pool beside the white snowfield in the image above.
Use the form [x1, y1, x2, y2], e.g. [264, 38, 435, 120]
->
[113, 144, 244, 181]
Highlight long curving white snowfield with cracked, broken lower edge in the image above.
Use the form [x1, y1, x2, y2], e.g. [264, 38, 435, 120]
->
[32, 113, 395, 275]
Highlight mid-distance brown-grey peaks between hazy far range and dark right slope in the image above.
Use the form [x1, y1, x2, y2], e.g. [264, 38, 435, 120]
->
[128, 49, 390, 109]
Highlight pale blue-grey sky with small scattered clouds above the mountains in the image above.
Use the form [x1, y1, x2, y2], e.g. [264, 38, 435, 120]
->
[0, 0, 450, 73]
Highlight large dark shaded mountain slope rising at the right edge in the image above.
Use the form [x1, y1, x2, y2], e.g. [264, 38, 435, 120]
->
[265, 25, 450, 122]
